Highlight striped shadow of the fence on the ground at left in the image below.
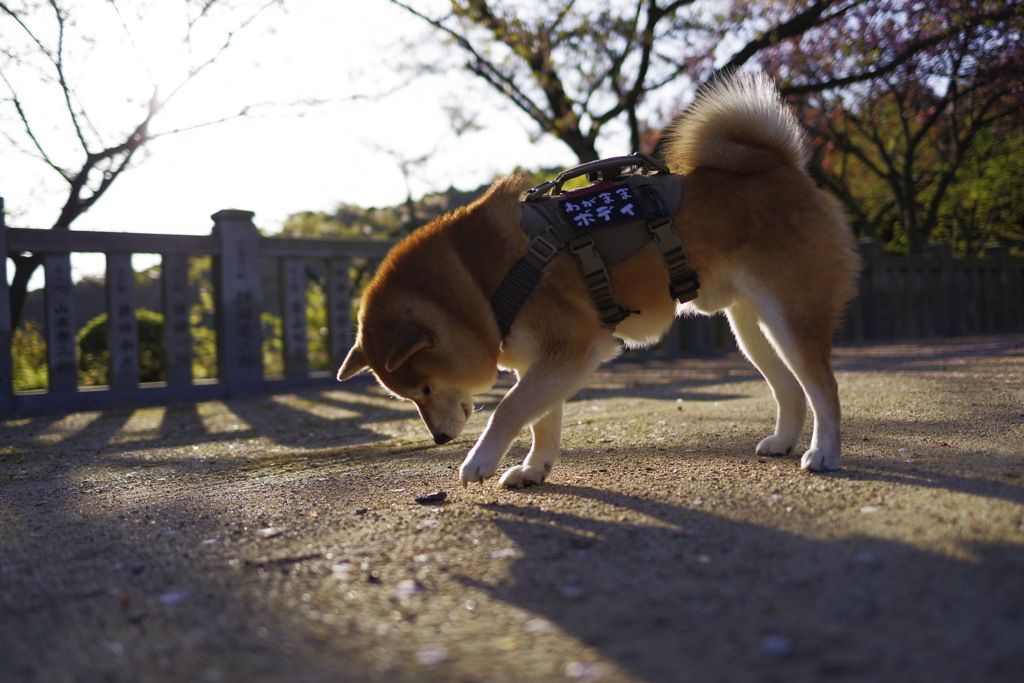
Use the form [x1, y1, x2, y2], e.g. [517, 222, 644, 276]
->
[0, 380, 417, 479]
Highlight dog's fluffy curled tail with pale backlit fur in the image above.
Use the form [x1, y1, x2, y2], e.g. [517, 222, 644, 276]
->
[665, 73, 807, 173]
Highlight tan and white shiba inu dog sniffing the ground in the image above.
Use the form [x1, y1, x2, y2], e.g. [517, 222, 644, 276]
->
[338, 75, 859, 487]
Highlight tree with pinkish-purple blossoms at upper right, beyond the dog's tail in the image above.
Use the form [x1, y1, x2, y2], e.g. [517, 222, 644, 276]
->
[760, 0, 1024, 254]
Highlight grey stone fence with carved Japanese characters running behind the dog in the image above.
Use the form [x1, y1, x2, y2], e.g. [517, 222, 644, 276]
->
[0, 205, 1024, 415]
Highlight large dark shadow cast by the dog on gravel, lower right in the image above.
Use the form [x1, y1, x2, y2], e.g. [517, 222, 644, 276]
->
[466, 486, 1024, 681]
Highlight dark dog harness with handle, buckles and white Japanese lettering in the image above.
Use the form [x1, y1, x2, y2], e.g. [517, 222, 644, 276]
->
[490, 154, 700, 339]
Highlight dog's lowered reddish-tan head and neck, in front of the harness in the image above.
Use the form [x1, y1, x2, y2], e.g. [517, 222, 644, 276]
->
[338, 177, 525, 443]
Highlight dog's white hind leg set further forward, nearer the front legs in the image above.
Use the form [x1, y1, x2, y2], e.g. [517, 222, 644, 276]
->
[726, 301, 807, 456]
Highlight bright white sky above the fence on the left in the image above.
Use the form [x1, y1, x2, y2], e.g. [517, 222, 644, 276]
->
[0, 0, 581, 246]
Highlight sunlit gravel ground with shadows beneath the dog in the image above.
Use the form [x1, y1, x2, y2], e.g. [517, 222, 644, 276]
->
[0, 335, 1024, 683]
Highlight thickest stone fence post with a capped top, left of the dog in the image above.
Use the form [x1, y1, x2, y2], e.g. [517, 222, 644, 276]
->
[212, 209, 263, 397]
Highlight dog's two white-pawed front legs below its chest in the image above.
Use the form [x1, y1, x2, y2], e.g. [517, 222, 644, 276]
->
[459, 352, 603, 485]
